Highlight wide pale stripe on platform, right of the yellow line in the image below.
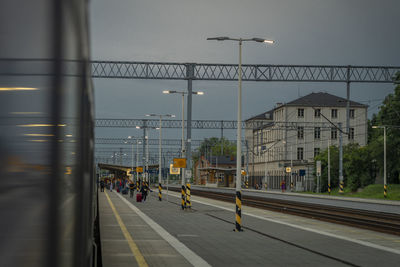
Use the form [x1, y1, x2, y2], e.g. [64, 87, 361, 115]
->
[115, 193, 211, 266]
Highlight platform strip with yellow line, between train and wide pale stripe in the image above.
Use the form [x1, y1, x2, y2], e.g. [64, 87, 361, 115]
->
[99, 190, 192, 267]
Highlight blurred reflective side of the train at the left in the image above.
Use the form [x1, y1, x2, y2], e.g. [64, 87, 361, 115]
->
[0, 0, 97, 267]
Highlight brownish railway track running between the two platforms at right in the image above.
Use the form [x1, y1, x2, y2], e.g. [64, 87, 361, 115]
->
[170, 188, 400, 235]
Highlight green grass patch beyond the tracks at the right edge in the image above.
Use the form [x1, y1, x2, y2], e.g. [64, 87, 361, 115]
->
[304, 184, 400, 200]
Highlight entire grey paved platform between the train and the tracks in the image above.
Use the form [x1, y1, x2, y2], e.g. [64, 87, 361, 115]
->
[99, 190, 400, 267]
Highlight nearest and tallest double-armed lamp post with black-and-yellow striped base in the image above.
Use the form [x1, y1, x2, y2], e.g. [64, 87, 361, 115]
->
[207, 37, 274, 231]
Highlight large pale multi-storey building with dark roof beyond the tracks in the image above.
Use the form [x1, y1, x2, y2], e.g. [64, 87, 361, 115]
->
[244, 93, 368, 190]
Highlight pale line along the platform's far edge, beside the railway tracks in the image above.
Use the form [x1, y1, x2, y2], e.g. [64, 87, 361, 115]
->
[166, 192, 400, 255]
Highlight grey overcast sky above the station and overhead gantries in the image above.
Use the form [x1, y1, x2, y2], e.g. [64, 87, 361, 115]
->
[90, 0, 400, 148]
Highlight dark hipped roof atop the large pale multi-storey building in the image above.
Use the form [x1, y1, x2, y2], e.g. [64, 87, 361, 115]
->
[278, 92, 367, 108]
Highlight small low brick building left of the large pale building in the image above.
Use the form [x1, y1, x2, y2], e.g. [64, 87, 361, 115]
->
[194, 156, 236, 187]
